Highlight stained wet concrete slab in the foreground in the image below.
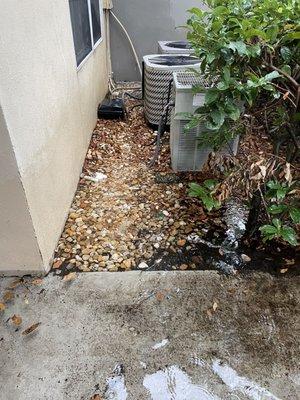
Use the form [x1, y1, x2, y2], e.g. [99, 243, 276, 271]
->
[0, 271, 300, 400]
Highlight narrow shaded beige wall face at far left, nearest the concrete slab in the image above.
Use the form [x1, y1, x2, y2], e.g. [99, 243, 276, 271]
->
[0, 108, 42, 274]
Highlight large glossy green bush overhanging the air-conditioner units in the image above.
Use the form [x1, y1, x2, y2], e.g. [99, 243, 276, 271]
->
[187, 0, 300, 158]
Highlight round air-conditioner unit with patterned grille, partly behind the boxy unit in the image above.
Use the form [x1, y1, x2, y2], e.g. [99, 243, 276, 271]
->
[143, 54, 200, 126]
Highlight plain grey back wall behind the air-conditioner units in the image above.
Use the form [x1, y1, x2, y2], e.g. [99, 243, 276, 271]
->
[111, 0, 209, 81]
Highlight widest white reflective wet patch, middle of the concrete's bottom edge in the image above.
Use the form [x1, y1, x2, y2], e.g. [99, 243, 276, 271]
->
[143, 365, 218, 400]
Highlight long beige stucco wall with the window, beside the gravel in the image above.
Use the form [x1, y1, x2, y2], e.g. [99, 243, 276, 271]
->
[0, 0, 107, 270]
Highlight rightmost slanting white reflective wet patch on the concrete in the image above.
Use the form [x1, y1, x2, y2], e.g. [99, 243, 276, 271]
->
[212, 360, 280, 400]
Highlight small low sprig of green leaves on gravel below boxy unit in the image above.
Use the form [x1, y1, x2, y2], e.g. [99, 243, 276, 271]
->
[188, 179, 220, 211]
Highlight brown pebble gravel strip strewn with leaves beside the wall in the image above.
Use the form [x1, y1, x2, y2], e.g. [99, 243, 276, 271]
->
[54, 103, 209, 271]
